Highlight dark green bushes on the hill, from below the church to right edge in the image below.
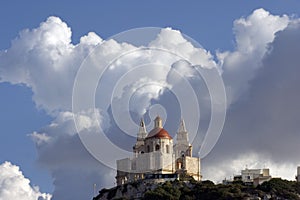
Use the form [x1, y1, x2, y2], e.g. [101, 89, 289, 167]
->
[144, 178, 300, 200]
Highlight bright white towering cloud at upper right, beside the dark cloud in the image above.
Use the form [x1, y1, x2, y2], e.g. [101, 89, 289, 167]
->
[217, 9, 291, 104]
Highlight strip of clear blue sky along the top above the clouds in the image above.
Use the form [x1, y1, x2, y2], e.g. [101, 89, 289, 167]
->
[0, 0, 299, 50]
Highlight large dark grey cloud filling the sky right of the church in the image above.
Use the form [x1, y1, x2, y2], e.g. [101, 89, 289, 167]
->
[203, 23, 300, 181]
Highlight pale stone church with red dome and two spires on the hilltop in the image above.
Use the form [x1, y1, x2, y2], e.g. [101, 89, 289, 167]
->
[116, 116, 201, 185]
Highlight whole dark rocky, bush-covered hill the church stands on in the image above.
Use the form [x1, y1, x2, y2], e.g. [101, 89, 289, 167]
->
[93, 178, 300, 200]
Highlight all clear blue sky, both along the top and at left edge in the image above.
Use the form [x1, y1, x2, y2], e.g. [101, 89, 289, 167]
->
[0, 0, 300, 199]
